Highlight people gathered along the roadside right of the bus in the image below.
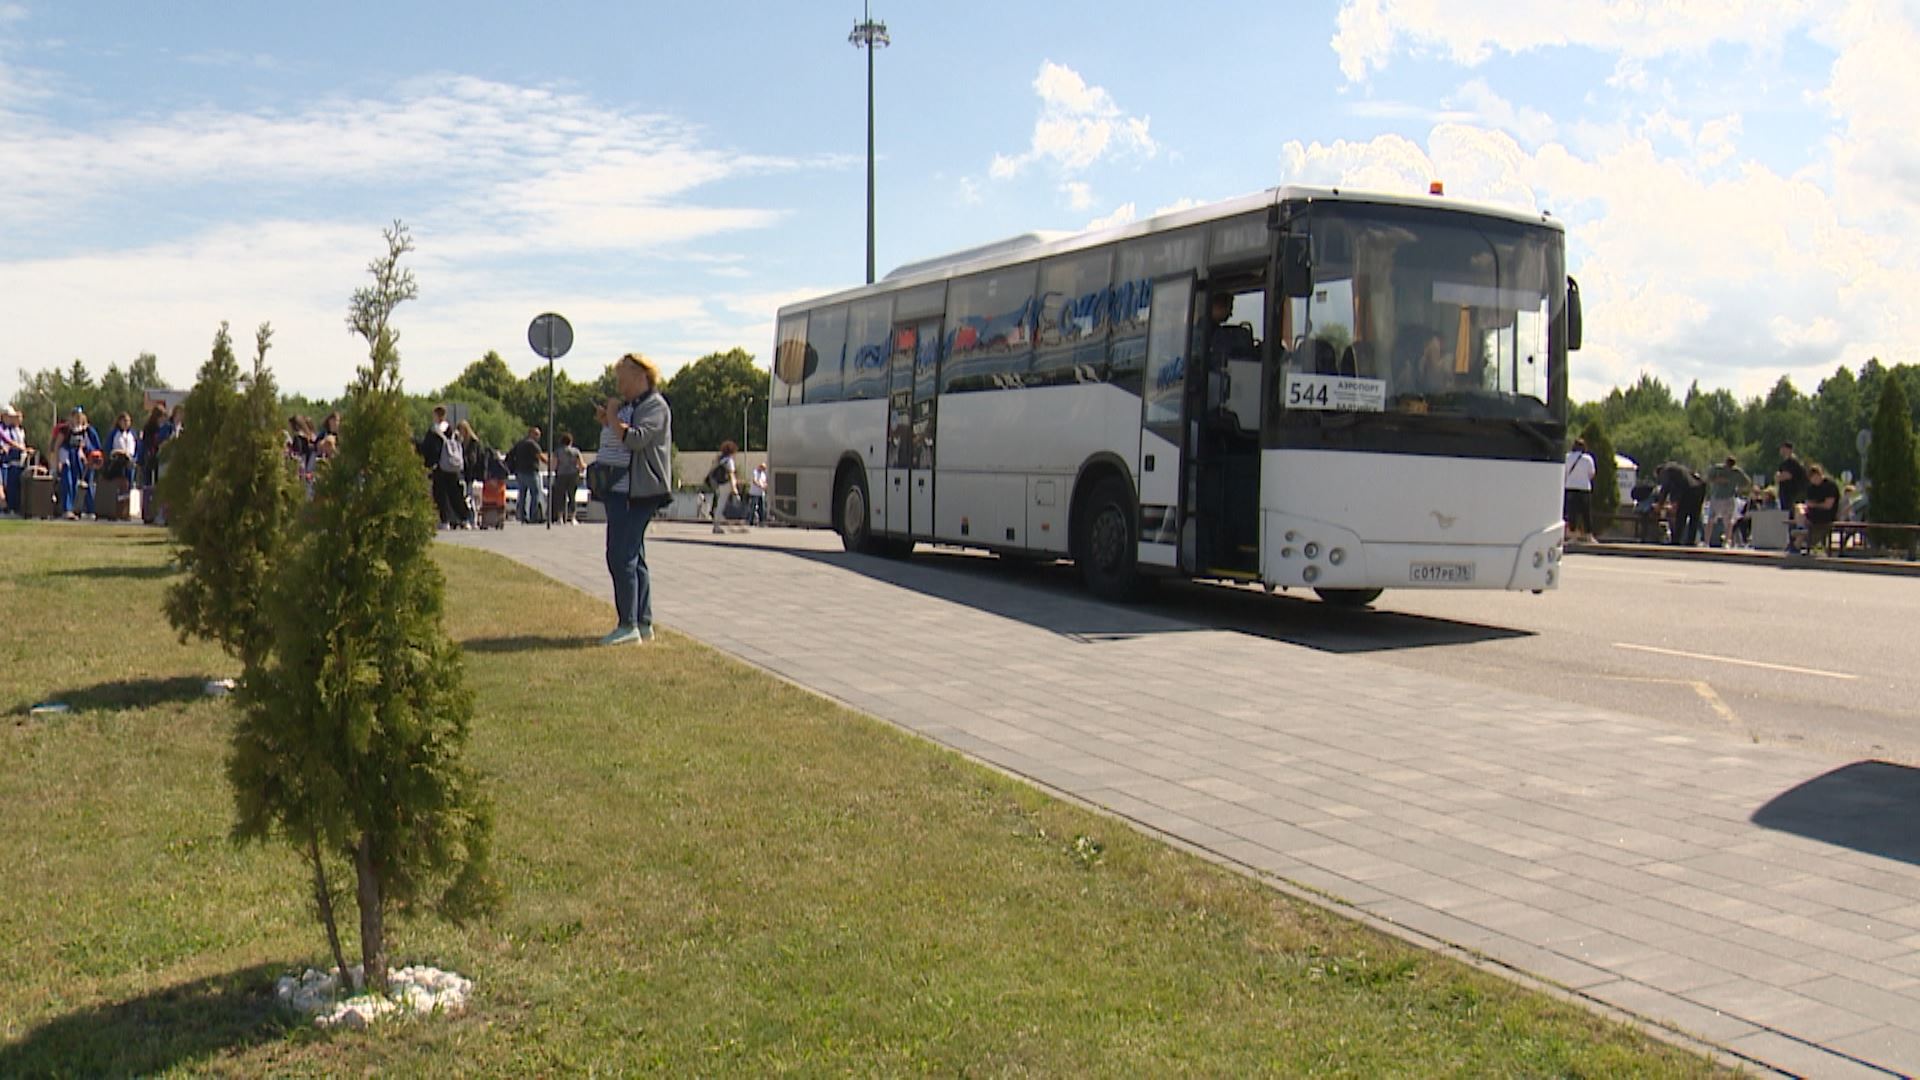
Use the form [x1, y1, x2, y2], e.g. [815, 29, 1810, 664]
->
[1565, 440, 1864, 553]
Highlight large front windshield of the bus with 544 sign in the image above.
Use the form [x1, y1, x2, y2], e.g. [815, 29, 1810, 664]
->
[1275, 204, 1567, 421]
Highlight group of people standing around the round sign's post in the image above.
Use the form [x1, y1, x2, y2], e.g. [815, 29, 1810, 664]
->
[419, 405, 584, 528]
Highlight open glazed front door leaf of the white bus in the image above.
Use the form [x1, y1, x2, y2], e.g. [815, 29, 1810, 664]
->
[1135, 273, 1194, 567]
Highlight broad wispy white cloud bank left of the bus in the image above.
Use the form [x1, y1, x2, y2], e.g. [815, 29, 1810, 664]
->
[0, 71, 839, 394]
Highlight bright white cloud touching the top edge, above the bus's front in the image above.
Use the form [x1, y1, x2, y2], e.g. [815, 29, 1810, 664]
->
[1332, 0, 1826, 83]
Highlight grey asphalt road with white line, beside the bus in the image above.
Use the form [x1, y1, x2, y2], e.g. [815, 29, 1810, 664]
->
[898, 548, 1920, 765]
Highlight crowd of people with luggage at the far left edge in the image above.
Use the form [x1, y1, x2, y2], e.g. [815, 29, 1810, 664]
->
[0, 405, 182, 521]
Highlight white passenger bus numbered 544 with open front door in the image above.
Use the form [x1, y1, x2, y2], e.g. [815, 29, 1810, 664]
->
[768, 186, 1580, 605]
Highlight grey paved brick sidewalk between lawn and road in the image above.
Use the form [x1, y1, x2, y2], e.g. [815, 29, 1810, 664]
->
[453, 525, 1920, 1076]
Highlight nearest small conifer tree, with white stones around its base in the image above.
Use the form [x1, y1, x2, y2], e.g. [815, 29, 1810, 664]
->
[228, 223, 495, 994]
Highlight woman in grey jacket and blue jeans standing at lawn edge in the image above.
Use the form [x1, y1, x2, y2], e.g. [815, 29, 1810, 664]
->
[593, 352, 674, 646]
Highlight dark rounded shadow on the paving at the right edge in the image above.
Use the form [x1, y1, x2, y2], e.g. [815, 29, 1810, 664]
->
[1753, 761, 1920, 865]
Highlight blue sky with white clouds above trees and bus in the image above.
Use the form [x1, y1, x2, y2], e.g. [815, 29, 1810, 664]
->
[0, 0, 1920, 396]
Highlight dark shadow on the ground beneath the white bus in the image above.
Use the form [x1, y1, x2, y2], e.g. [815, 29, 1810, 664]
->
[764, 550, 1532, 653]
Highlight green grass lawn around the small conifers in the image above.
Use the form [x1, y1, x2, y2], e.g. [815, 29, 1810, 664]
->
[0, 525, 1711, 1076]
